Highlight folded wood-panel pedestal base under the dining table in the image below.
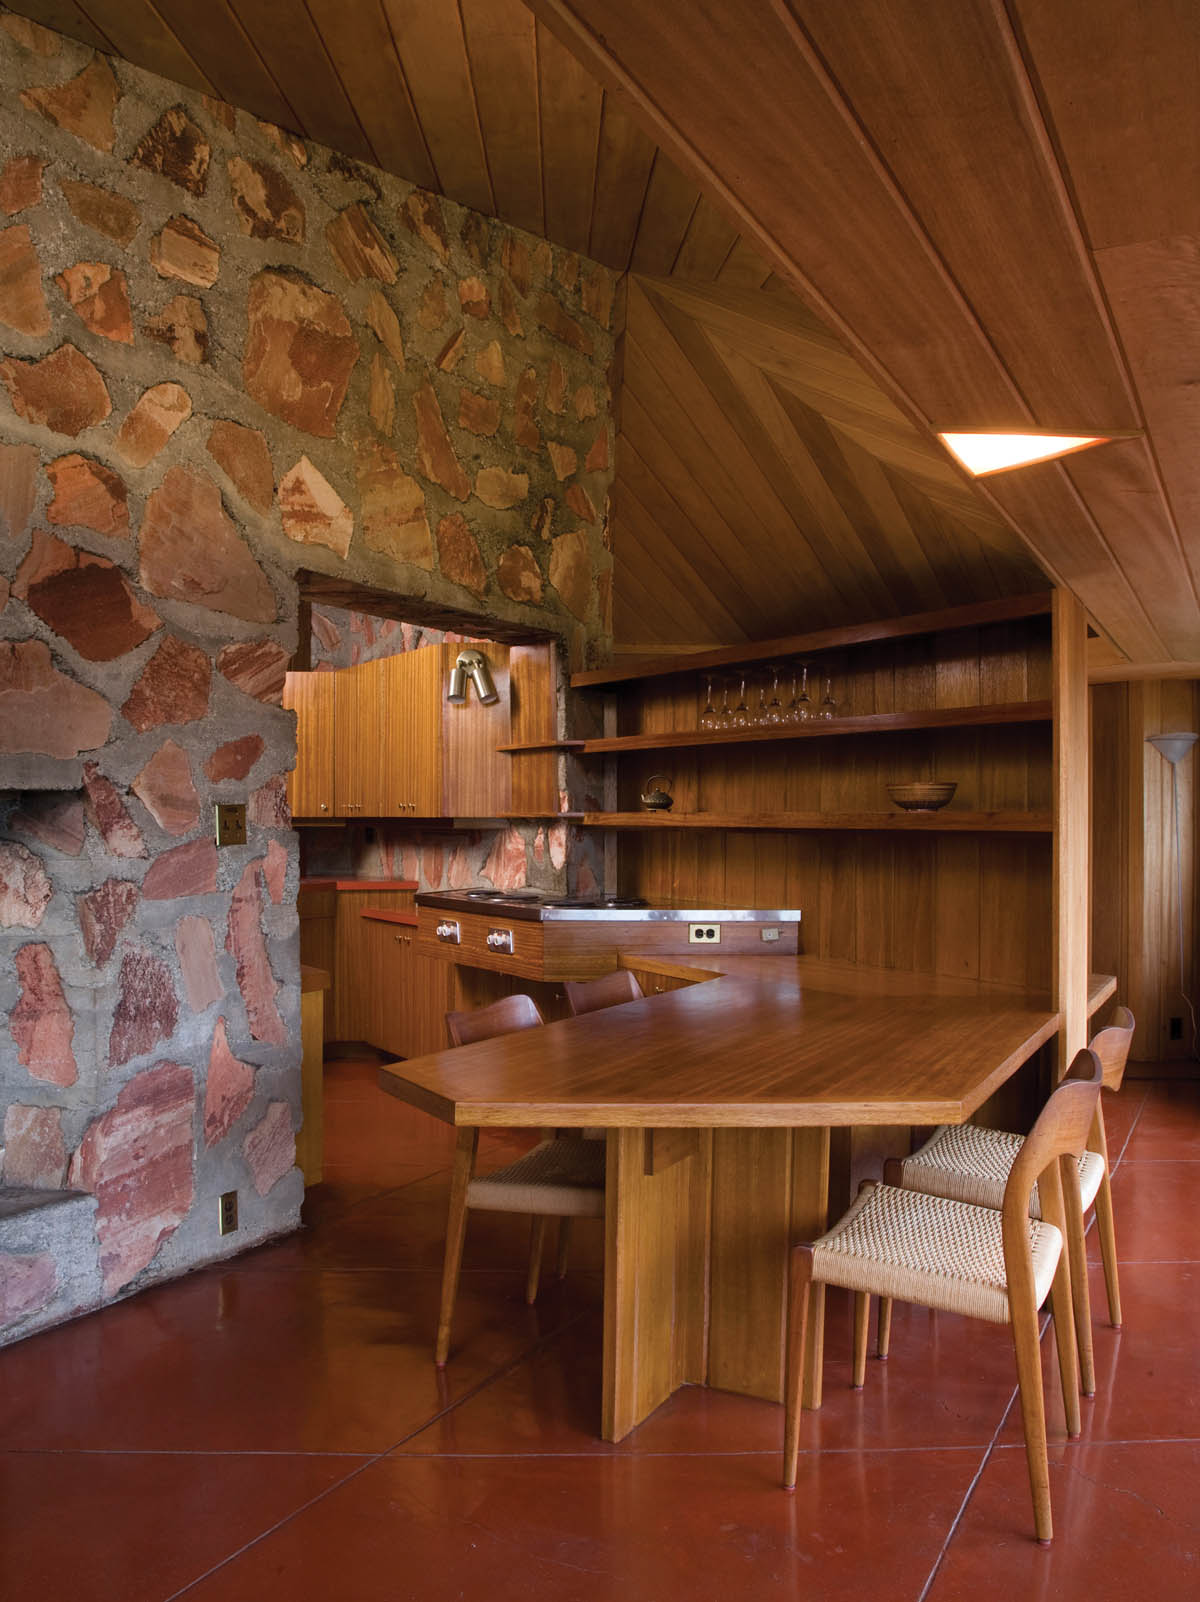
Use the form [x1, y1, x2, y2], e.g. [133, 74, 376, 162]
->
[601, 1128, 830, 1440]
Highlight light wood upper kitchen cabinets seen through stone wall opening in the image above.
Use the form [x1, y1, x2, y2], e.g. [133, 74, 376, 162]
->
[293, 644, 513, 819]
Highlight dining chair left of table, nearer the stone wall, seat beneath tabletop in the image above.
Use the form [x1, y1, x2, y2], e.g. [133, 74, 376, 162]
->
[434, 995, 604, 1368]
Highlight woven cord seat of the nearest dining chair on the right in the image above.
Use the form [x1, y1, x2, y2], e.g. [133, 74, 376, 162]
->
[812, 1184, 1062, 1323]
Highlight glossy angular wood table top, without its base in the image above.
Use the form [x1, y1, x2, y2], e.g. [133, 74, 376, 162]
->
[380, 952, 1112, 1128]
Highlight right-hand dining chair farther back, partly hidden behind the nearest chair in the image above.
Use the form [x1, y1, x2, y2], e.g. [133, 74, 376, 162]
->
[875, 1006, 1134, 1397]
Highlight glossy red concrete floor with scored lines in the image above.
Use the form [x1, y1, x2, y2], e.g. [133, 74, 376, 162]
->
[0, 1062, 1200, 1602]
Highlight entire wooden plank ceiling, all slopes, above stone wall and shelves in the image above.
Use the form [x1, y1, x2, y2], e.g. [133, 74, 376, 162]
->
[14, 0, 1200, 673]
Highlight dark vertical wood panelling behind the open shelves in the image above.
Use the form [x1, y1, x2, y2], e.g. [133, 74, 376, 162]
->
[620, 618, 1053, 987]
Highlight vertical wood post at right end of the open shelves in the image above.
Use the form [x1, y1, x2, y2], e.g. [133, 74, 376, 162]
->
[1054, 590, 1089, 1075]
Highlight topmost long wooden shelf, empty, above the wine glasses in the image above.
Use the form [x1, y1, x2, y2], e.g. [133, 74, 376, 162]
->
[570, 591, 1051, 689]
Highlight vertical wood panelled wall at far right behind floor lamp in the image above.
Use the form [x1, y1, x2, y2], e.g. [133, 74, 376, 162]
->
[1091, 679, 1200, 1062]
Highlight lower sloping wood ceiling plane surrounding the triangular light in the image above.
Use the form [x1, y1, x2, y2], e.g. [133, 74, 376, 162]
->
[529, 0, 1200, 662]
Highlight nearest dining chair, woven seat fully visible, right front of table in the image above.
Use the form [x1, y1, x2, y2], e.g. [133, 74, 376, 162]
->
[783, 1048, 1104, 1546]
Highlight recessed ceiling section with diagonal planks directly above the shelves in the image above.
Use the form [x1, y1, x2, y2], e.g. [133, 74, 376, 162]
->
[614, 277, 1045, 650]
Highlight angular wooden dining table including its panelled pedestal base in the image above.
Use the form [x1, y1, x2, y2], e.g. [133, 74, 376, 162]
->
[380, 952, 1115, 1440]
